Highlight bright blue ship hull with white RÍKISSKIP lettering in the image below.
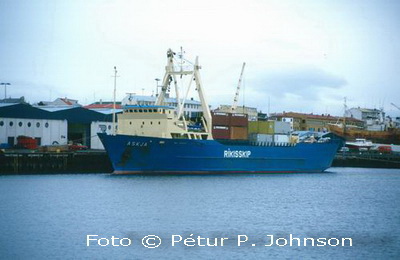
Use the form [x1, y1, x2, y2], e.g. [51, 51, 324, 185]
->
[99, 134, 340, 174]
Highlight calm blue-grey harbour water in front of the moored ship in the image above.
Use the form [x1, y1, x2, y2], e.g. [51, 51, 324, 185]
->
[0, 168, 400, 259]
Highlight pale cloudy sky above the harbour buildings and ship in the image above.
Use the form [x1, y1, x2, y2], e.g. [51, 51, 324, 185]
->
[0, 0, 400, 114]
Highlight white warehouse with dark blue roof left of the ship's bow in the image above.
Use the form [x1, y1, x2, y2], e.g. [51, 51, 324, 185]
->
[0, 104, 116, 149]
